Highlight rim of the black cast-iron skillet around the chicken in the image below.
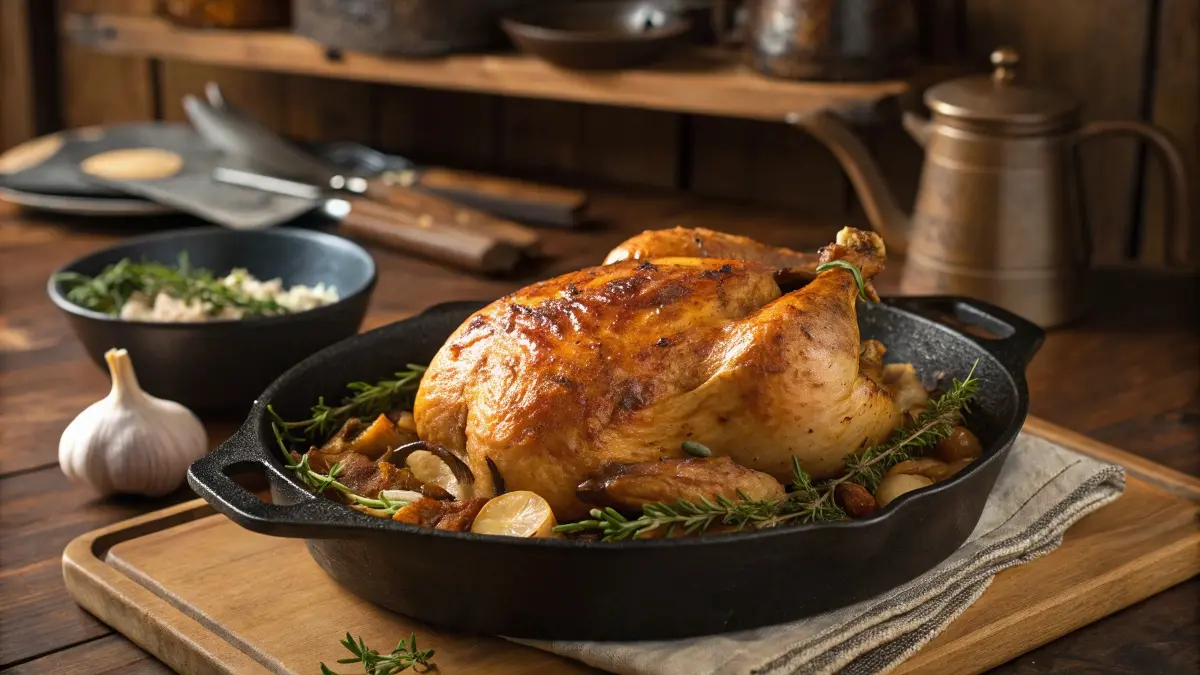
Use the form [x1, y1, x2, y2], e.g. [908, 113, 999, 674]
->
[204, 295, 1043, 552]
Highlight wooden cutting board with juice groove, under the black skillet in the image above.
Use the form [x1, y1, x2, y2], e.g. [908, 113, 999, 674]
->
[62, 419, 1200, 675]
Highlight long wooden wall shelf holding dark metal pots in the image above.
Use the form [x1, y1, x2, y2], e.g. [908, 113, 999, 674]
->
[62, 14, 947, 121]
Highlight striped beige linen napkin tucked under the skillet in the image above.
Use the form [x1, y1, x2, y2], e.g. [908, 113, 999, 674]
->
[516, 434, 1124, 675]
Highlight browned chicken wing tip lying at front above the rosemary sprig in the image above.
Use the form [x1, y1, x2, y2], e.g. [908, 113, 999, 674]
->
[575, 456, 784, 513]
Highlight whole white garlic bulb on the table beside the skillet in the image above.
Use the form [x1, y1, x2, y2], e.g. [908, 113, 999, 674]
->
[59, 350, 209, 496]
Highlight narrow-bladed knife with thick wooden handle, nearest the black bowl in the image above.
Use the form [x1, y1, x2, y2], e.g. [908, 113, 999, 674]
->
[212, 166, 521, 273]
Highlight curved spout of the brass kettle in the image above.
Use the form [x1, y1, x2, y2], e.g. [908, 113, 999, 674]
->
[787, 112, 910, 255]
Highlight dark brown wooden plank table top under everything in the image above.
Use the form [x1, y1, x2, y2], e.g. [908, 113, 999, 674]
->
[0, 193, 1200, 674]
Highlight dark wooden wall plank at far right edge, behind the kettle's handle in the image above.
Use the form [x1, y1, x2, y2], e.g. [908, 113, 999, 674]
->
[1139, 0, 1200, 265]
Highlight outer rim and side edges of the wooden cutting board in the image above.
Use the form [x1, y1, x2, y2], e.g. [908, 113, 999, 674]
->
[62, 417, 1200, 675]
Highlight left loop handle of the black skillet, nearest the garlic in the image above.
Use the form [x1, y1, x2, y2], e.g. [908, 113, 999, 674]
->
[187, 424, 344, 539]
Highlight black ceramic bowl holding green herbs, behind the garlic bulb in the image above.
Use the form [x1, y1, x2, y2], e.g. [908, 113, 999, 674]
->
[47, 227, 376, 414]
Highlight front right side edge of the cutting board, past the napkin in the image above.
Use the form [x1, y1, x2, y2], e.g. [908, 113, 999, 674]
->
[894, 528, 1200, 675]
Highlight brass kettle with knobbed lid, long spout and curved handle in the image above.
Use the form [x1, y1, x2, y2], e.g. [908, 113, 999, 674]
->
[788, 48, 1190, 327]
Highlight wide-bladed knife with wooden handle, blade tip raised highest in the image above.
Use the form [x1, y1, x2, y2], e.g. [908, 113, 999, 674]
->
[184, 88, 552, 252]
